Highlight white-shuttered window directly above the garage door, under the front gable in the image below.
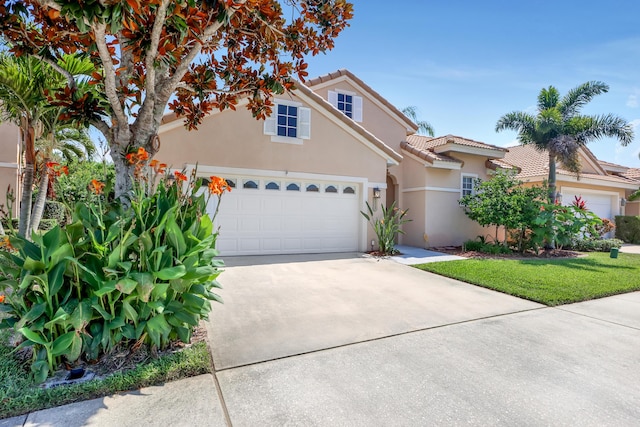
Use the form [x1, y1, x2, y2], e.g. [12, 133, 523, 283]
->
[264, 100, 311, 144]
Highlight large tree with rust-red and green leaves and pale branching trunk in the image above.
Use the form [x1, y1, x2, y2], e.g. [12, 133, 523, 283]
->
[0, 0, 353, 197]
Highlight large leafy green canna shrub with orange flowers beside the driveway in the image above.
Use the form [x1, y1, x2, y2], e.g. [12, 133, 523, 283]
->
[0, 150, 230, 381]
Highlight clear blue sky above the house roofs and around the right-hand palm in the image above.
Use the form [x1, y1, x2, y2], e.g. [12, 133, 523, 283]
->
[302, 0, 640, 167]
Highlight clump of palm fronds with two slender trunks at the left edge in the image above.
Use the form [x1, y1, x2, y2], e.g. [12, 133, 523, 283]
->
[0, 54, 93, 236]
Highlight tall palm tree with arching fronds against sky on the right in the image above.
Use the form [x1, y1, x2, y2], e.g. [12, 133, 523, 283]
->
[496, 81, 633, 203]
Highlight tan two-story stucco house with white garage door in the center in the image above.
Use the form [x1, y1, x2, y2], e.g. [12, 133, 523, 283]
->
[156, 70, 507, 256]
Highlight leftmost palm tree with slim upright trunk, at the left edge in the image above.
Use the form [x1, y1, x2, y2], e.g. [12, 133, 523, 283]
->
[0, 54, 94, 236]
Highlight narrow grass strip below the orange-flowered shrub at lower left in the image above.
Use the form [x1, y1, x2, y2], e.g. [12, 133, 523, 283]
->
[0, 331, 211, 418]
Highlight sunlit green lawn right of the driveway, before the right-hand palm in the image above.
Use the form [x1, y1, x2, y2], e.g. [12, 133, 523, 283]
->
[415, 252, 640, 306]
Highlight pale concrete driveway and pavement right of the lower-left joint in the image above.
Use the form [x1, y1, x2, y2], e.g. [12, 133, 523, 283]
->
[208, 254, 640, 426]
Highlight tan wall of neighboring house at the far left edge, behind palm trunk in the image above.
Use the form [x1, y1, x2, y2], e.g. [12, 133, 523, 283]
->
[0, 123, 20, 218]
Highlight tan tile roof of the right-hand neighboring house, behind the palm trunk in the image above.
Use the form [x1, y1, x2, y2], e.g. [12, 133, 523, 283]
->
[502, 145, 635, 184]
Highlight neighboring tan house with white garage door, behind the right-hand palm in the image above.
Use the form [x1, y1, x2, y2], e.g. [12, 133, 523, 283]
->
[502, 145, 640, 221]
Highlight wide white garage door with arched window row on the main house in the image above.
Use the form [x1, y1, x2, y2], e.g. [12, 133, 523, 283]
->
[209, 177, 361, 256]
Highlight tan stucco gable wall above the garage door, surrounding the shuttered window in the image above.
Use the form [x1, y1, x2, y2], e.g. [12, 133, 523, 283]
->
[156, 98, 386, 183]
